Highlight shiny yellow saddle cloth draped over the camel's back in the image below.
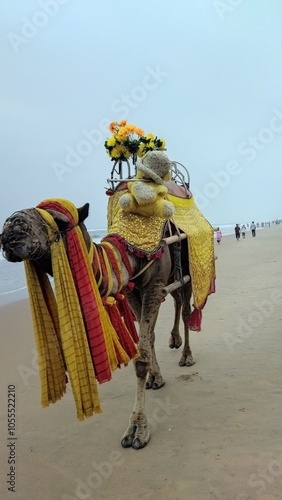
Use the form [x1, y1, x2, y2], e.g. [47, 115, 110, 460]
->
[107, 191, 215, 309]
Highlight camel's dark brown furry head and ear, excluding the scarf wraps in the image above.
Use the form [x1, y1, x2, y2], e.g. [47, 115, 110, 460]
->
[0, 203, 89, 262]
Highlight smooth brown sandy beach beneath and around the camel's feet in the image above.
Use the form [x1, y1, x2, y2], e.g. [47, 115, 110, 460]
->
[0, 226, 282, 500]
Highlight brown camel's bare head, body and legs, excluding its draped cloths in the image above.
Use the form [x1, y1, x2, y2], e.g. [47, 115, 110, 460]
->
[1, 198, 198, 450]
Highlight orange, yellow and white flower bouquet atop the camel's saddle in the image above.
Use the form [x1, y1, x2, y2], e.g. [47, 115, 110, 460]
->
[104, 120, 166, 163]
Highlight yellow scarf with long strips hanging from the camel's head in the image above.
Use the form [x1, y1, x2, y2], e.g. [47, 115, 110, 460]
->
[24, 200, 136, 420]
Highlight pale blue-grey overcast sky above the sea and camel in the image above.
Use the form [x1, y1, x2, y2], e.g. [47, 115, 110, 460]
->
[0, 0, 282, 228]
